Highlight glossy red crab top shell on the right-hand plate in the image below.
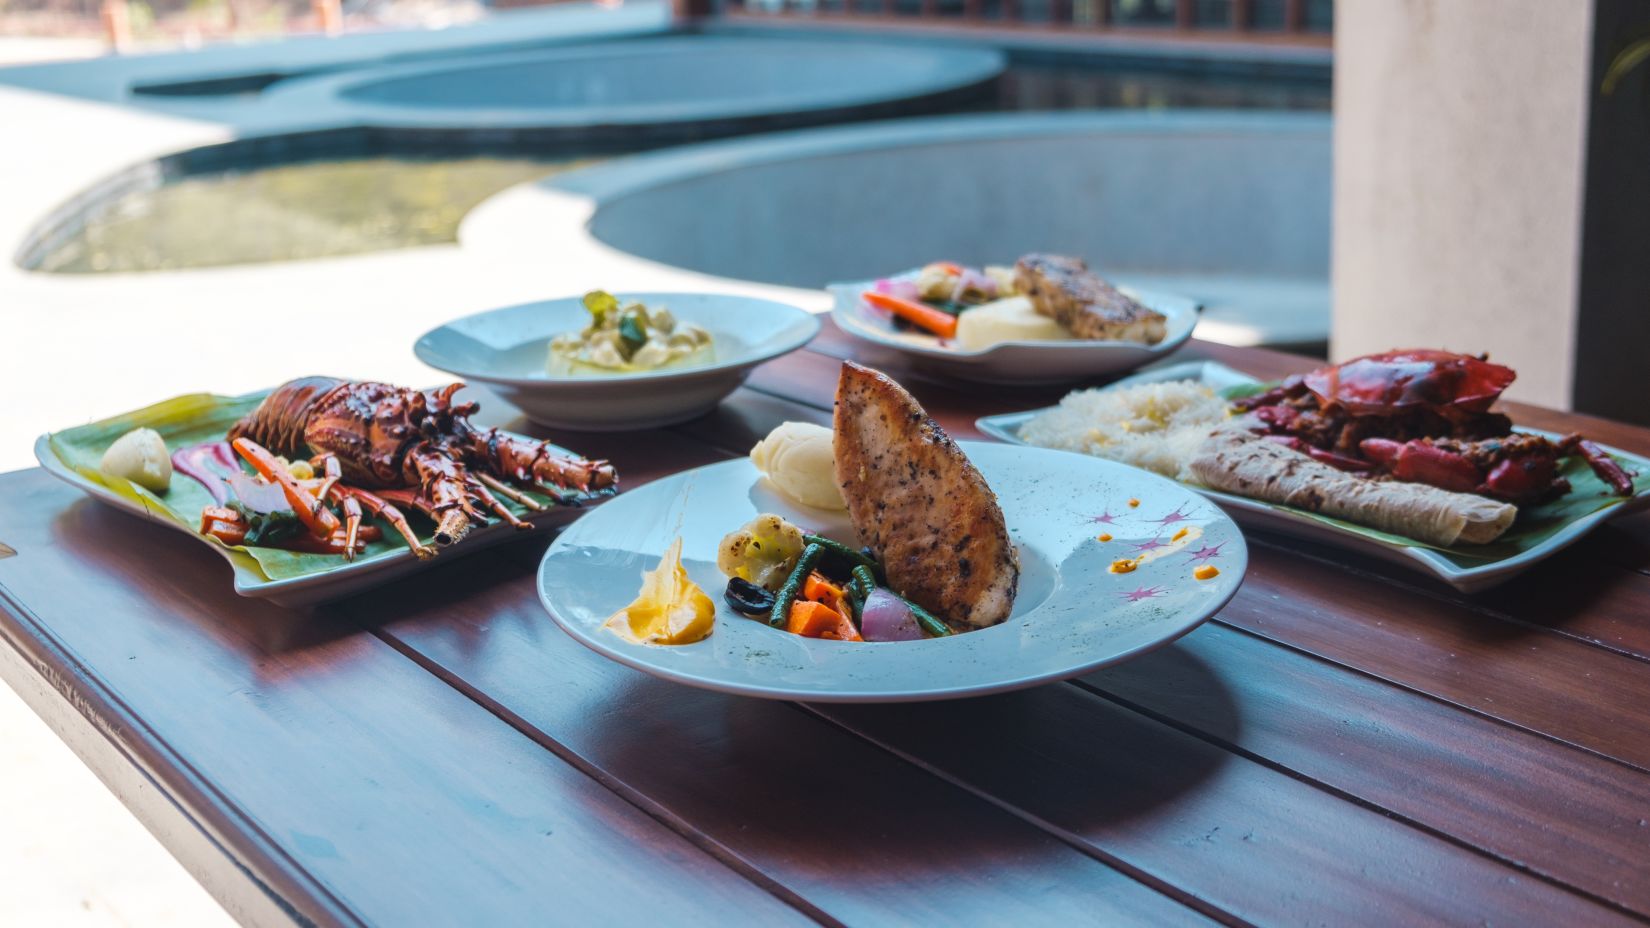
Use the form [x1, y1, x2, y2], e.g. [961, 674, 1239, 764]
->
[1302, 348, 1518, 416]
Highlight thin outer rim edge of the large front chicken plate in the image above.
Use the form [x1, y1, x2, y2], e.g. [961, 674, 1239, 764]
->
[533, 439, 1249, 705]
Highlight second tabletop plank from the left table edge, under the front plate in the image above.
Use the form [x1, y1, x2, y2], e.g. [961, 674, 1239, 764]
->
[377, 426, 1227, 925]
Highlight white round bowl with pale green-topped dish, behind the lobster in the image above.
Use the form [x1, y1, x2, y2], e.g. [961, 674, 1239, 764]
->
[413, 292, 820, 431]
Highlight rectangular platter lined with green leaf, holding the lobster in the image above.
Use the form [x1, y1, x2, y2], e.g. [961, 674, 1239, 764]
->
[35, 384, 599, 608]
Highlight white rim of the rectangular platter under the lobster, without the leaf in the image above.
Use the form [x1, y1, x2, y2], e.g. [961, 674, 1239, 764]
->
[35, 434, 587, 609]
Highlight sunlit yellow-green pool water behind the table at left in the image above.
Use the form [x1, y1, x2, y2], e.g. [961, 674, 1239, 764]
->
[31, 155, 592, 274]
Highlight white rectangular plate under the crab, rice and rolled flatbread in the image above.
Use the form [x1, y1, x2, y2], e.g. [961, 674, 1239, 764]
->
[975, 362, 1650, 593]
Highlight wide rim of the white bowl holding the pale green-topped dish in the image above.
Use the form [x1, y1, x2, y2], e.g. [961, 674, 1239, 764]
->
[413, 291, 820, 390]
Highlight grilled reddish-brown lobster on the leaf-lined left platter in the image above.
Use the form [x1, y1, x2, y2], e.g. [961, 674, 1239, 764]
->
[228, 376, 619, 558]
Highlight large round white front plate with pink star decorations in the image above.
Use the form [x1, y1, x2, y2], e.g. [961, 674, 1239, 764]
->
[538, 441, 1247, 702]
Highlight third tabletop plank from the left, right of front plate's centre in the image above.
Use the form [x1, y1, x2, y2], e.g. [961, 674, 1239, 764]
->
[810, 677, 1635, 925]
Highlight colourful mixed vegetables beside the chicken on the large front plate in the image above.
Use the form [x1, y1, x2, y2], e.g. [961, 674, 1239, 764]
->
[716, 514, 952, 641]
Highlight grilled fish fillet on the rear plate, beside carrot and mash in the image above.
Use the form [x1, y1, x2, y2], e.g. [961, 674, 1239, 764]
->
[1015, 254, 1167, 345]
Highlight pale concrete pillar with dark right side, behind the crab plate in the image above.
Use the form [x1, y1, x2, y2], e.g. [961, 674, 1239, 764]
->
[1332, 0, 1650, 424]
